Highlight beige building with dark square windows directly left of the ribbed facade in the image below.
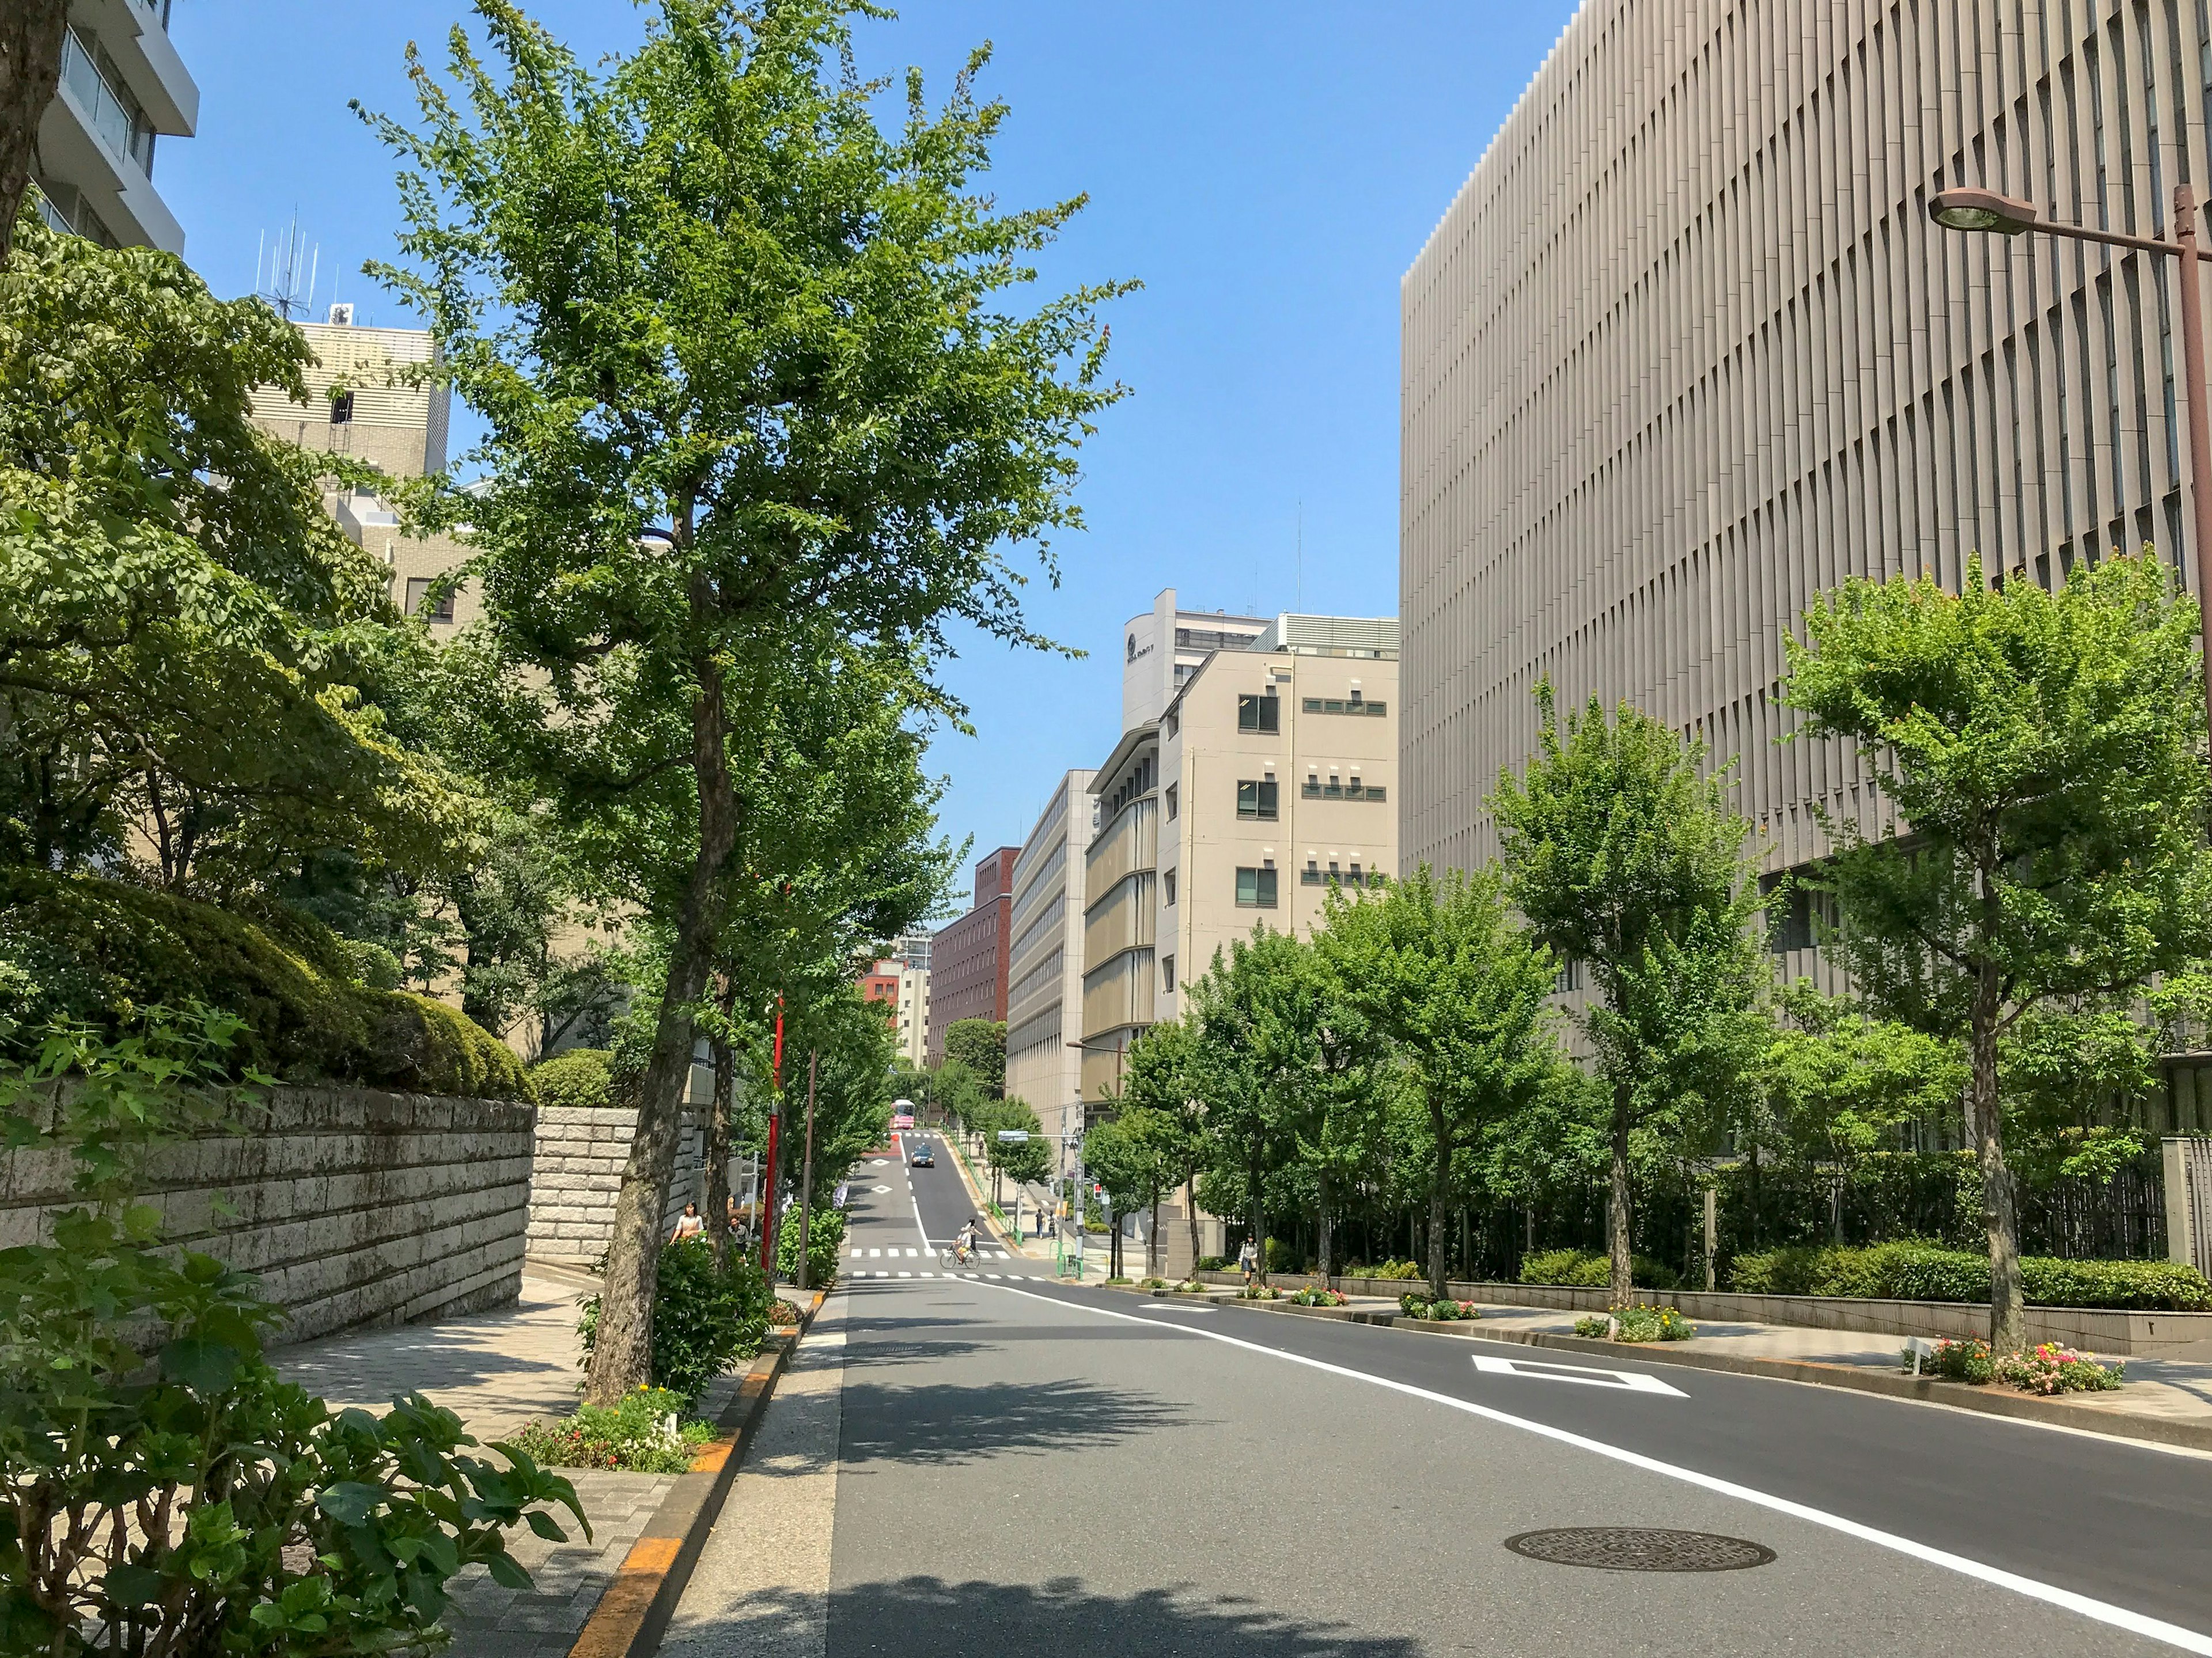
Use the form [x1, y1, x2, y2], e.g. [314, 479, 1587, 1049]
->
[1082, 614, 1398, 1105]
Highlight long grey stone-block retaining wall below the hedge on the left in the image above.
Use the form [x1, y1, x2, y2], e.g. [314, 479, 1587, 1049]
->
[0, 1088, 537, 1342]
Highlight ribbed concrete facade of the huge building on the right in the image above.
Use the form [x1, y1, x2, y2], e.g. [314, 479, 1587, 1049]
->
[1400, 0, 2212, 897]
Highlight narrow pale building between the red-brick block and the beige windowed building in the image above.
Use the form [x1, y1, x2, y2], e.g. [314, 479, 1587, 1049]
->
[1006, 772, 1097, 1174]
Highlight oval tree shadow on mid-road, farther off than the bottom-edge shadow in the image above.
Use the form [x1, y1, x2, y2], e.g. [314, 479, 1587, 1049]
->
[843, 1371, 1192, 1468]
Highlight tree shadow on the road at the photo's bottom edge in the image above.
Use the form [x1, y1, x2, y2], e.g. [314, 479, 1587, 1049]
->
[809, 1576, 1420, 1658]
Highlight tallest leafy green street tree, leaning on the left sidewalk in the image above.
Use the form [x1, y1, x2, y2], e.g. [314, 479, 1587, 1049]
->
[372, 0, 1119, 1402]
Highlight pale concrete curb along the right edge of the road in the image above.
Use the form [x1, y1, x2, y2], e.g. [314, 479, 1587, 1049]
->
[1228, 1300, 2212, 1450]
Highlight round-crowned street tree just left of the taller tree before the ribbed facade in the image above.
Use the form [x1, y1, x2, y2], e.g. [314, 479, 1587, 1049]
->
[1314, 864, 1559, 1297]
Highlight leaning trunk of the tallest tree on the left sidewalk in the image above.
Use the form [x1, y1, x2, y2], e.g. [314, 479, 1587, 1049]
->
[584, 619, 737, 1406]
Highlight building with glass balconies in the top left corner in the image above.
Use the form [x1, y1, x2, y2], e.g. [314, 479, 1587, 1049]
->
[31, 0, 199, 254]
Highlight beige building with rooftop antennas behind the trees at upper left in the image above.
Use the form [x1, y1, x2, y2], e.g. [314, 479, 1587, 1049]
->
[255, 305, 478, 635]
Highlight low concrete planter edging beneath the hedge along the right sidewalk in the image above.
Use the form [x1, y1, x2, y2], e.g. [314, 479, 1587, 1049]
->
[1199, 1273, 2212, 1357]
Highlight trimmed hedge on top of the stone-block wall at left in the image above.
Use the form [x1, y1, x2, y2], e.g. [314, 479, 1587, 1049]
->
[0, 869, 531, 1099]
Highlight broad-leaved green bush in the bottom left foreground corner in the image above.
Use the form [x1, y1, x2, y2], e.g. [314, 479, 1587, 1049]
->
[0, 1010, 588, 1658]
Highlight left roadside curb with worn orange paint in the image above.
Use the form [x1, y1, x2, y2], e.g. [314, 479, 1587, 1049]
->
[569, 1289, 830, 1658]
